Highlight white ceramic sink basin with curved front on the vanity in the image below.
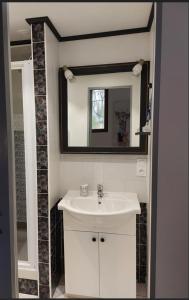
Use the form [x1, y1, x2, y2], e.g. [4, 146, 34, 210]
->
[58, 191, 140, 226]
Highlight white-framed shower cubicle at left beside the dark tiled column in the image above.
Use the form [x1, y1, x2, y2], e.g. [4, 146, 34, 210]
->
[11, 60, 37, 278]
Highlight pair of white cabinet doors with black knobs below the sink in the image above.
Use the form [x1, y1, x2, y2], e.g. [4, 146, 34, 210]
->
[64, 225, 136, 298]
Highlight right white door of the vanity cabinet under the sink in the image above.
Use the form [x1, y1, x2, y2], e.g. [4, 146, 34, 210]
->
[99, 233, 136, 298]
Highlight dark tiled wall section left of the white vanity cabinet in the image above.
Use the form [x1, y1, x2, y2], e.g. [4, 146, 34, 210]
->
[50, 200, 64, 296]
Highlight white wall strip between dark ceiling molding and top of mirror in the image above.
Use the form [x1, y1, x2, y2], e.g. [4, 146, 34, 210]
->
[59, 32, 150, 66]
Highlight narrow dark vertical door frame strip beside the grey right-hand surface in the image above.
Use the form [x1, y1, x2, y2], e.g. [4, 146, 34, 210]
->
[148, 3, 162, 299]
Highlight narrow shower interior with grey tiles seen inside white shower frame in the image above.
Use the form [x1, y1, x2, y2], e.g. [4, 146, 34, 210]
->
[12, 69, 28, 260]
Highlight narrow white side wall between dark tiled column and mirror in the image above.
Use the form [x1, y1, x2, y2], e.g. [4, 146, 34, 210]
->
[45, 25, 60, 208]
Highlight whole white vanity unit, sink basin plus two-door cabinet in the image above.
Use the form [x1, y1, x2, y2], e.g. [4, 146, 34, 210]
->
[58, 191, 140, 298]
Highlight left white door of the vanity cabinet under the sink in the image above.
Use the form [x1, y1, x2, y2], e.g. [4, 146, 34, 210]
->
[64, 231, 99, 297]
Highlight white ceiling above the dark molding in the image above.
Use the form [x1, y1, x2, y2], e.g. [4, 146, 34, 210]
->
[9, 2, 152, 41]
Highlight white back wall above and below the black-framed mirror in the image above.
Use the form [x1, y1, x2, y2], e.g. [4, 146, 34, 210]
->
[59, 33, 150, 202]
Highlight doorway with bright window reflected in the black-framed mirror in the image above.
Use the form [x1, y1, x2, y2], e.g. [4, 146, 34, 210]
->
[89, 87, 134, 147]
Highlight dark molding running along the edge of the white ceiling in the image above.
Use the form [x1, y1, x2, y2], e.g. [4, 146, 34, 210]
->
[11, 3, 154, 46]
